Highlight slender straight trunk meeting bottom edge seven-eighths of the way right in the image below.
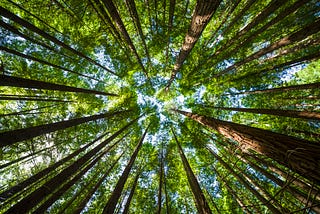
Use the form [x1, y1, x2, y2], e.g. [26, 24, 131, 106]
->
[206, 147, 281, 214]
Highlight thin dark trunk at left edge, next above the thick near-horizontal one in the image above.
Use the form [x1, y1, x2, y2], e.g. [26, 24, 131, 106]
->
[0, 46, 101, 82]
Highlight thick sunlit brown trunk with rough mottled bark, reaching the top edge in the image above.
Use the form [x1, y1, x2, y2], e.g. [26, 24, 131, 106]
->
[166, 0, 221, 91]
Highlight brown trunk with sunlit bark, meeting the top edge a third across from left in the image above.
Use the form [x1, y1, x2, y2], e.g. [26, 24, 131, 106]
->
[103, 0, 149, 78]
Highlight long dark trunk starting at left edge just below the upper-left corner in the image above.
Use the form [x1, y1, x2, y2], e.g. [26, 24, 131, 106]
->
[0, 6, 117, 75]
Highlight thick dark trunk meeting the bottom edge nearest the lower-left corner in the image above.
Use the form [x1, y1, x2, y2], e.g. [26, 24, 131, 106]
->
[5, 118, 139, 214]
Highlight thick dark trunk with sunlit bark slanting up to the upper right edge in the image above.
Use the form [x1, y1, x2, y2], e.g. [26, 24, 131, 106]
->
[213, 19, 320, 77]
